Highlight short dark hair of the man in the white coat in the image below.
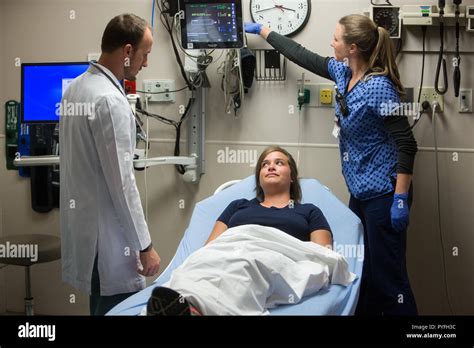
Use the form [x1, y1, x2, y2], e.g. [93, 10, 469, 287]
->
[101, 13, 151, 53]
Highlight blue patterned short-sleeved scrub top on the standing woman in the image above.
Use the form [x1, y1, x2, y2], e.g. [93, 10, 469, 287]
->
[328, 58, 400, 200]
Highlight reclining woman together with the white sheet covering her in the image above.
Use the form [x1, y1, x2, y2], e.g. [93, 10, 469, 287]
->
[147, 147, 355, 315]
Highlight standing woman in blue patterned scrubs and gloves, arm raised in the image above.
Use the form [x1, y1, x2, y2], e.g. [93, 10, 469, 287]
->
[245, 15, 417, 315]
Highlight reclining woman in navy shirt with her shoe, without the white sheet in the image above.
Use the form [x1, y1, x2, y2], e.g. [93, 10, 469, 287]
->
[147, 146, 332, 315]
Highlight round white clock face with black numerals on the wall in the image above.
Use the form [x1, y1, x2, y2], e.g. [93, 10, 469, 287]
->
[250, 0, 311, 36]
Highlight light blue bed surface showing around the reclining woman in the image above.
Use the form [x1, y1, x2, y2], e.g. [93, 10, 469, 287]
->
[108, 176, 363, 315]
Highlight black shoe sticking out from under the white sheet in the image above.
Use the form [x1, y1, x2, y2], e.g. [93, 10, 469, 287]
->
[146, 286, 191, 316]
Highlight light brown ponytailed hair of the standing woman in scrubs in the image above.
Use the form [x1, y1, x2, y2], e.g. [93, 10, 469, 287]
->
[339, 14, 405, 98]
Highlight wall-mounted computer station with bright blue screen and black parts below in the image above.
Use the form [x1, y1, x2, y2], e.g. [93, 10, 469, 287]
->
[20, 62, 89, 213]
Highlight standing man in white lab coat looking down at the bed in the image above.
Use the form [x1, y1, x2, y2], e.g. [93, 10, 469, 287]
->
[59, 14, 160, 315]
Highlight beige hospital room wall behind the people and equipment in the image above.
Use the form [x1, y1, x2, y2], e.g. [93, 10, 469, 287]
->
[0, 0, 474, 315]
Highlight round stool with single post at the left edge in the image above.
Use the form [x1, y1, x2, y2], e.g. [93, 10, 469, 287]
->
[0, 234, 61, 315]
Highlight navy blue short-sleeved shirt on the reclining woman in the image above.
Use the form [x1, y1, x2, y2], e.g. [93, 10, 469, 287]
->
[217, 198, 332, 242]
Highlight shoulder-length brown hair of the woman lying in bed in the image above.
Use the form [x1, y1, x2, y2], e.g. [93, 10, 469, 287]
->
[255, 146, 301, 203]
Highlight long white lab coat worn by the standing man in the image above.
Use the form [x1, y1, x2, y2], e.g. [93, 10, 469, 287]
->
[59, 66, 151, 296]
